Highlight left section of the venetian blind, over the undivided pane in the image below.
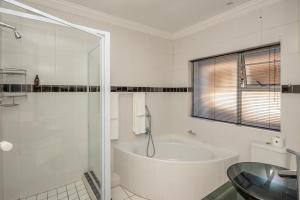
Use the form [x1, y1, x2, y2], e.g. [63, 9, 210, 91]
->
[193, 54, 238, 123]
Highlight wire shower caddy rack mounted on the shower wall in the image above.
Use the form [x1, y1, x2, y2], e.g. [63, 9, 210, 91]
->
[0, 68, 27, 107]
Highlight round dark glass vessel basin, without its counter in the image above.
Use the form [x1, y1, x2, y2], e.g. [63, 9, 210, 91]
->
[227, 162, 297, 200]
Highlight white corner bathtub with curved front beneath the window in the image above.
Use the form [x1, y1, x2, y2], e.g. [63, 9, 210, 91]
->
[114, 135, 238, 200]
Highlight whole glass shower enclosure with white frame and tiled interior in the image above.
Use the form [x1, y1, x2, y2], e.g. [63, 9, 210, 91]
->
[0, 0, 111, 200]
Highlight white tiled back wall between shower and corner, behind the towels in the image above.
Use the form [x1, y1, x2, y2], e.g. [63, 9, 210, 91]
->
[24, 1, 173, 139]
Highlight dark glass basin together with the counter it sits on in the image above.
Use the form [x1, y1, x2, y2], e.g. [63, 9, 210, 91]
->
[203, 162, 297, 200]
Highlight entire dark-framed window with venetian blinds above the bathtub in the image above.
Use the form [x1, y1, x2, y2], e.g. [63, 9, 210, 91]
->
[192, 45, 280, 130]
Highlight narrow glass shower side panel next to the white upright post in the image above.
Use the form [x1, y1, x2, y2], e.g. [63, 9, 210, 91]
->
[88, 41, 110, 199]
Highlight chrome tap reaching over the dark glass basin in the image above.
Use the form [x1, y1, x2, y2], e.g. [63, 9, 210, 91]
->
[278, 149, 300, 199]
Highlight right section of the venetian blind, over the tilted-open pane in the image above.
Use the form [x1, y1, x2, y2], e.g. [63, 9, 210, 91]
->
[240, 46, 280, 130]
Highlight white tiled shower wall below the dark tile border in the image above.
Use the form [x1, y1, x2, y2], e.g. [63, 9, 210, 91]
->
[2, 93, 87, 199]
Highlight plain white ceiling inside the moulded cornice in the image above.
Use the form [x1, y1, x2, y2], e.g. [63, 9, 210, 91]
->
[61, 0, 251, 33]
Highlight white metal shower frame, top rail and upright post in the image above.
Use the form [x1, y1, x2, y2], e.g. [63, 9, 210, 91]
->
[0, 0, 111, 200]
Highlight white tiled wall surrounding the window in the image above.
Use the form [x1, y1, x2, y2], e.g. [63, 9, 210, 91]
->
[170, 0, 300, 161]
